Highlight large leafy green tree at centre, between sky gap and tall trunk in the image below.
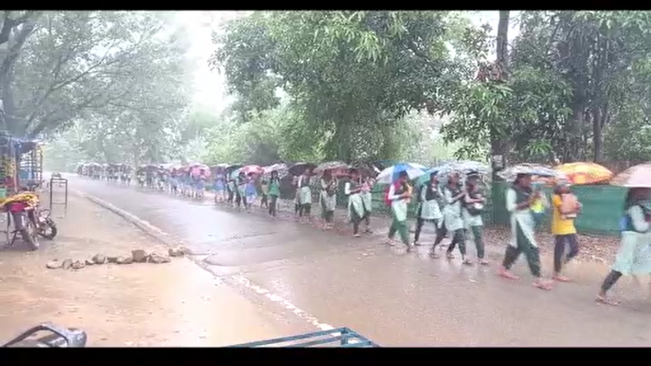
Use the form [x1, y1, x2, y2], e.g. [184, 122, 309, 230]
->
[212, 11, 486, 160]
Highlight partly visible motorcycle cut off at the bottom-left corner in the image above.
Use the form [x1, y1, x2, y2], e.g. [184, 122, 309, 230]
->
[1, 323, 88, 348]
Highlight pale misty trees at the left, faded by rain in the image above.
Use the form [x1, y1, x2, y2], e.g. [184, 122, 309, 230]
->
[0, 11, 190, 170]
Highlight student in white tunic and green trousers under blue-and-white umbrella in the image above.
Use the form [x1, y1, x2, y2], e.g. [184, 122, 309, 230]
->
[387, 171, 412, 252]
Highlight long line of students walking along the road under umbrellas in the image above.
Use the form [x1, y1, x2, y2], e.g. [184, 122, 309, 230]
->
[77, 160, 651, 305]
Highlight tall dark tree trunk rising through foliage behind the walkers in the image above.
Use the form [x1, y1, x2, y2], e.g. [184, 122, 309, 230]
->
[490, 10, 510, 176]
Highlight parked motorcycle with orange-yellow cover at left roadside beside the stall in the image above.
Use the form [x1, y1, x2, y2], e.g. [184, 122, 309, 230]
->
[2, 192, 58, 250]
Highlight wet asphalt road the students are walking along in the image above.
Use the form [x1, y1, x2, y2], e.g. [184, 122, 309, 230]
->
[65, 175, 651, 347]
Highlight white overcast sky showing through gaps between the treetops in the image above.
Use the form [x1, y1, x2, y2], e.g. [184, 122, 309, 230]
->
[176, 11, 519, 113]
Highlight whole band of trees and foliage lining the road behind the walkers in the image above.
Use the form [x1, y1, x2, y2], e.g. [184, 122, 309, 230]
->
[26, 11, 651, 171]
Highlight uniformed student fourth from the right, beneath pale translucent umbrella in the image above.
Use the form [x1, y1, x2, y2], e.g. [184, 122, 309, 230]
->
[461, 174, 488, 265]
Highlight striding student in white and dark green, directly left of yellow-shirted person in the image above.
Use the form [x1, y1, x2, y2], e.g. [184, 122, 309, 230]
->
[498, 174, 552, 290]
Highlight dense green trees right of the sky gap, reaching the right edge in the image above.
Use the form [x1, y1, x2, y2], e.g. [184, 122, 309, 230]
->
[212, 11, 651, 167]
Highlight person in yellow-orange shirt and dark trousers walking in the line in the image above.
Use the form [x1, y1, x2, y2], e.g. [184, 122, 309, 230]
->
[552, 183, 581, 282]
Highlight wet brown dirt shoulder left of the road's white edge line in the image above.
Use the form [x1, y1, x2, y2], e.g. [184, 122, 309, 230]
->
[0, 195, 291, 346]
